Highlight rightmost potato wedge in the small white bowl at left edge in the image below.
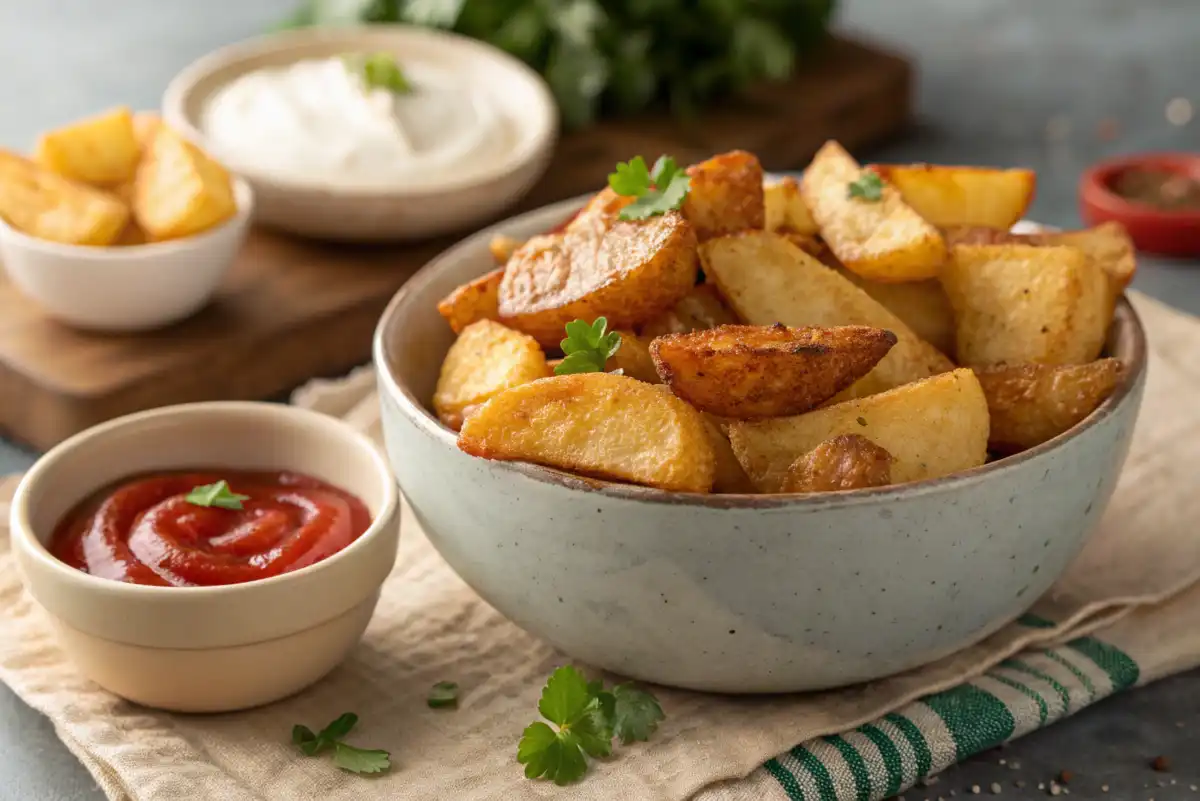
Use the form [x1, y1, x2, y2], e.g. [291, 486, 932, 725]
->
[133, 125, 238, 241]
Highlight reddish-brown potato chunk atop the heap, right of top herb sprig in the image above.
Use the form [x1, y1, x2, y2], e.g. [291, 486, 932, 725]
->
[683, 150, 766, 237]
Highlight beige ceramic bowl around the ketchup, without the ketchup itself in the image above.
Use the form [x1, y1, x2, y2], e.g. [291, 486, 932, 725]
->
[11, 403, 400, 712]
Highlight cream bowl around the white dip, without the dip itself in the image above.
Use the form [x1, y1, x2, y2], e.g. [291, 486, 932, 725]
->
[162, 25, 558, 242]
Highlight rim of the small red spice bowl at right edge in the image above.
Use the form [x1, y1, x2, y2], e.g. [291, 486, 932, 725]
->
[1079, 151, 1200, 225]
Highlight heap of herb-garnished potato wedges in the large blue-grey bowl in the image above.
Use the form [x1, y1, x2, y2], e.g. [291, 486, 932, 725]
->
[433, 143, 1135, 494]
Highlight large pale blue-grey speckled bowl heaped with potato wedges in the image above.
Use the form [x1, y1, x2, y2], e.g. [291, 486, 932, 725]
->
[374, 143, 1146, 693]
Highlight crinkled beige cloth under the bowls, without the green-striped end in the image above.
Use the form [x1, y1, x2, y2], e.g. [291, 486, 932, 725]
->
[0, 288, 1200, 801]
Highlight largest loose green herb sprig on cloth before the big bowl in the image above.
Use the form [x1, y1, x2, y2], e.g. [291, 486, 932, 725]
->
[517, 664, 665, 785]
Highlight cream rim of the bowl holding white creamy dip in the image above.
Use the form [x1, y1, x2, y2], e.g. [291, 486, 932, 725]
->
[162, 23, 559, 199]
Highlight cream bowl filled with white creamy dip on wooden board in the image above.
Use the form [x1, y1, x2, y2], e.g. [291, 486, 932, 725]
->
[163, 25, 558, 242]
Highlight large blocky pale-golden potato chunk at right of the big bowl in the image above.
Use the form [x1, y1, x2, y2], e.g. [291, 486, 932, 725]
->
[942, 245, 1112, 367]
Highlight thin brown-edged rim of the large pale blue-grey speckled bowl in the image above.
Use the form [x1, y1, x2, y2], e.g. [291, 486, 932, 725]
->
[372, 193, 1147, 510]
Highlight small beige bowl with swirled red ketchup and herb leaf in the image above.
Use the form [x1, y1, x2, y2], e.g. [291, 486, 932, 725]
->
[11, 403, 400, 712]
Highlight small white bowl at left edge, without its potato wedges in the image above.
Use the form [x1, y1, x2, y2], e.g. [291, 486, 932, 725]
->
[0, 177, 254, 332]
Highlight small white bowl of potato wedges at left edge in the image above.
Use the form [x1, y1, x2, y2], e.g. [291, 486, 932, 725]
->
[0, 108, 253, 331]
